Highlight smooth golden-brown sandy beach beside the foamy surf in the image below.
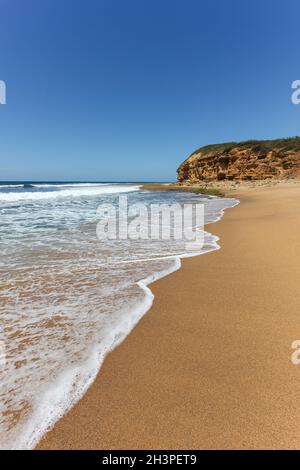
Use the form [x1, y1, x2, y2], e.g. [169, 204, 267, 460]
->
[38, 184, 300, 449]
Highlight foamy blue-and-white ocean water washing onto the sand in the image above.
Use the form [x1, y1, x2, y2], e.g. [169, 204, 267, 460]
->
[0, 182, 237, 449]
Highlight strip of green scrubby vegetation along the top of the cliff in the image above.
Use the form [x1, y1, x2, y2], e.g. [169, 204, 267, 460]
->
[188, 136, 300, 158]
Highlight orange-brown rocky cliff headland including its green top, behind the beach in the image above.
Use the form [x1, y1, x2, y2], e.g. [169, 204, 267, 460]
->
[177, 137, 300, 183]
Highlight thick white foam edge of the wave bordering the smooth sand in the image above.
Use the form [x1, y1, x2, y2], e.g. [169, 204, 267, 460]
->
[12, 258, 181, 450]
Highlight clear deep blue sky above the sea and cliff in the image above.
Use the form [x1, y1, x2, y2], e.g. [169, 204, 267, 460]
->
[0, 0, 300, 181]
